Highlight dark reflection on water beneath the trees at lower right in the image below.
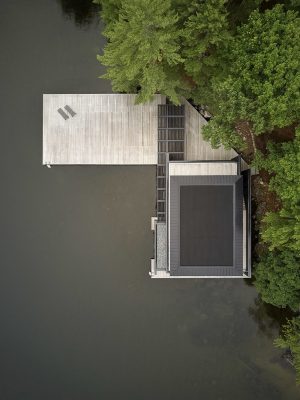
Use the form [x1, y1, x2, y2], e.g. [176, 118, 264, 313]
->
[248, 295, 294, 339]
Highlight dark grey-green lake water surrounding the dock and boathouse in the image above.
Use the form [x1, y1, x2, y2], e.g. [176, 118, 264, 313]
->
[0, 0, 300, 400]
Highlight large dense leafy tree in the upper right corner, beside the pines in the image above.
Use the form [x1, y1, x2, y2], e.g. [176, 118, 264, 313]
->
[205, 5, 300, 146]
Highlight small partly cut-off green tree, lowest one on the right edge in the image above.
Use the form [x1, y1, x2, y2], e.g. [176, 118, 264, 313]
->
[275, 317, 300, 384]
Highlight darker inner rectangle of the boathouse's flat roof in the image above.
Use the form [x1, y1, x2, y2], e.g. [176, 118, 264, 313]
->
[180, 185, 234, 266]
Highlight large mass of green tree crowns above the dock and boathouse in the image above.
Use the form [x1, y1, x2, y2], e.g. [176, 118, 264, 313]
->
[95, 0, 300, 148]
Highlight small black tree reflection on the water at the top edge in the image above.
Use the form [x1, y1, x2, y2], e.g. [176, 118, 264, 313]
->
[57, 0, 100, 27]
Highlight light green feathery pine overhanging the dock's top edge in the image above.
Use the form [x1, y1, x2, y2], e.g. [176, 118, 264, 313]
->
[98, 0, 183, 104]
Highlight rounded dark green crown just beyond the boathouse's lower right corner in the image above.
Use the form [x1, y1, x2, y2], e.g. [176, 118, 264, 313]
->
[254, 251, 300, 310]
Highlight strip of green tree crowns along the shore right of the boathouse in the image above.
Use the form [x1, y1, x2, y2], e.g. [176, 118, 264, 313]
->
[255, 129, 300, 309]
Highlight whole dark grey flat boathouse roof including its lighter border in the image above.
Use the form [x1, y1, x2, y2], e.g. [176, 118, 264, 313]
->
[168, 175, 243, 277]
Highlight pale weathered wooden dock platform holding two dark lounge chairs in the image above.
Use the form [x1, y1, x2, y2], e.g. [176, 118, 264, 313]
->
[43, 94, 165, 165]
